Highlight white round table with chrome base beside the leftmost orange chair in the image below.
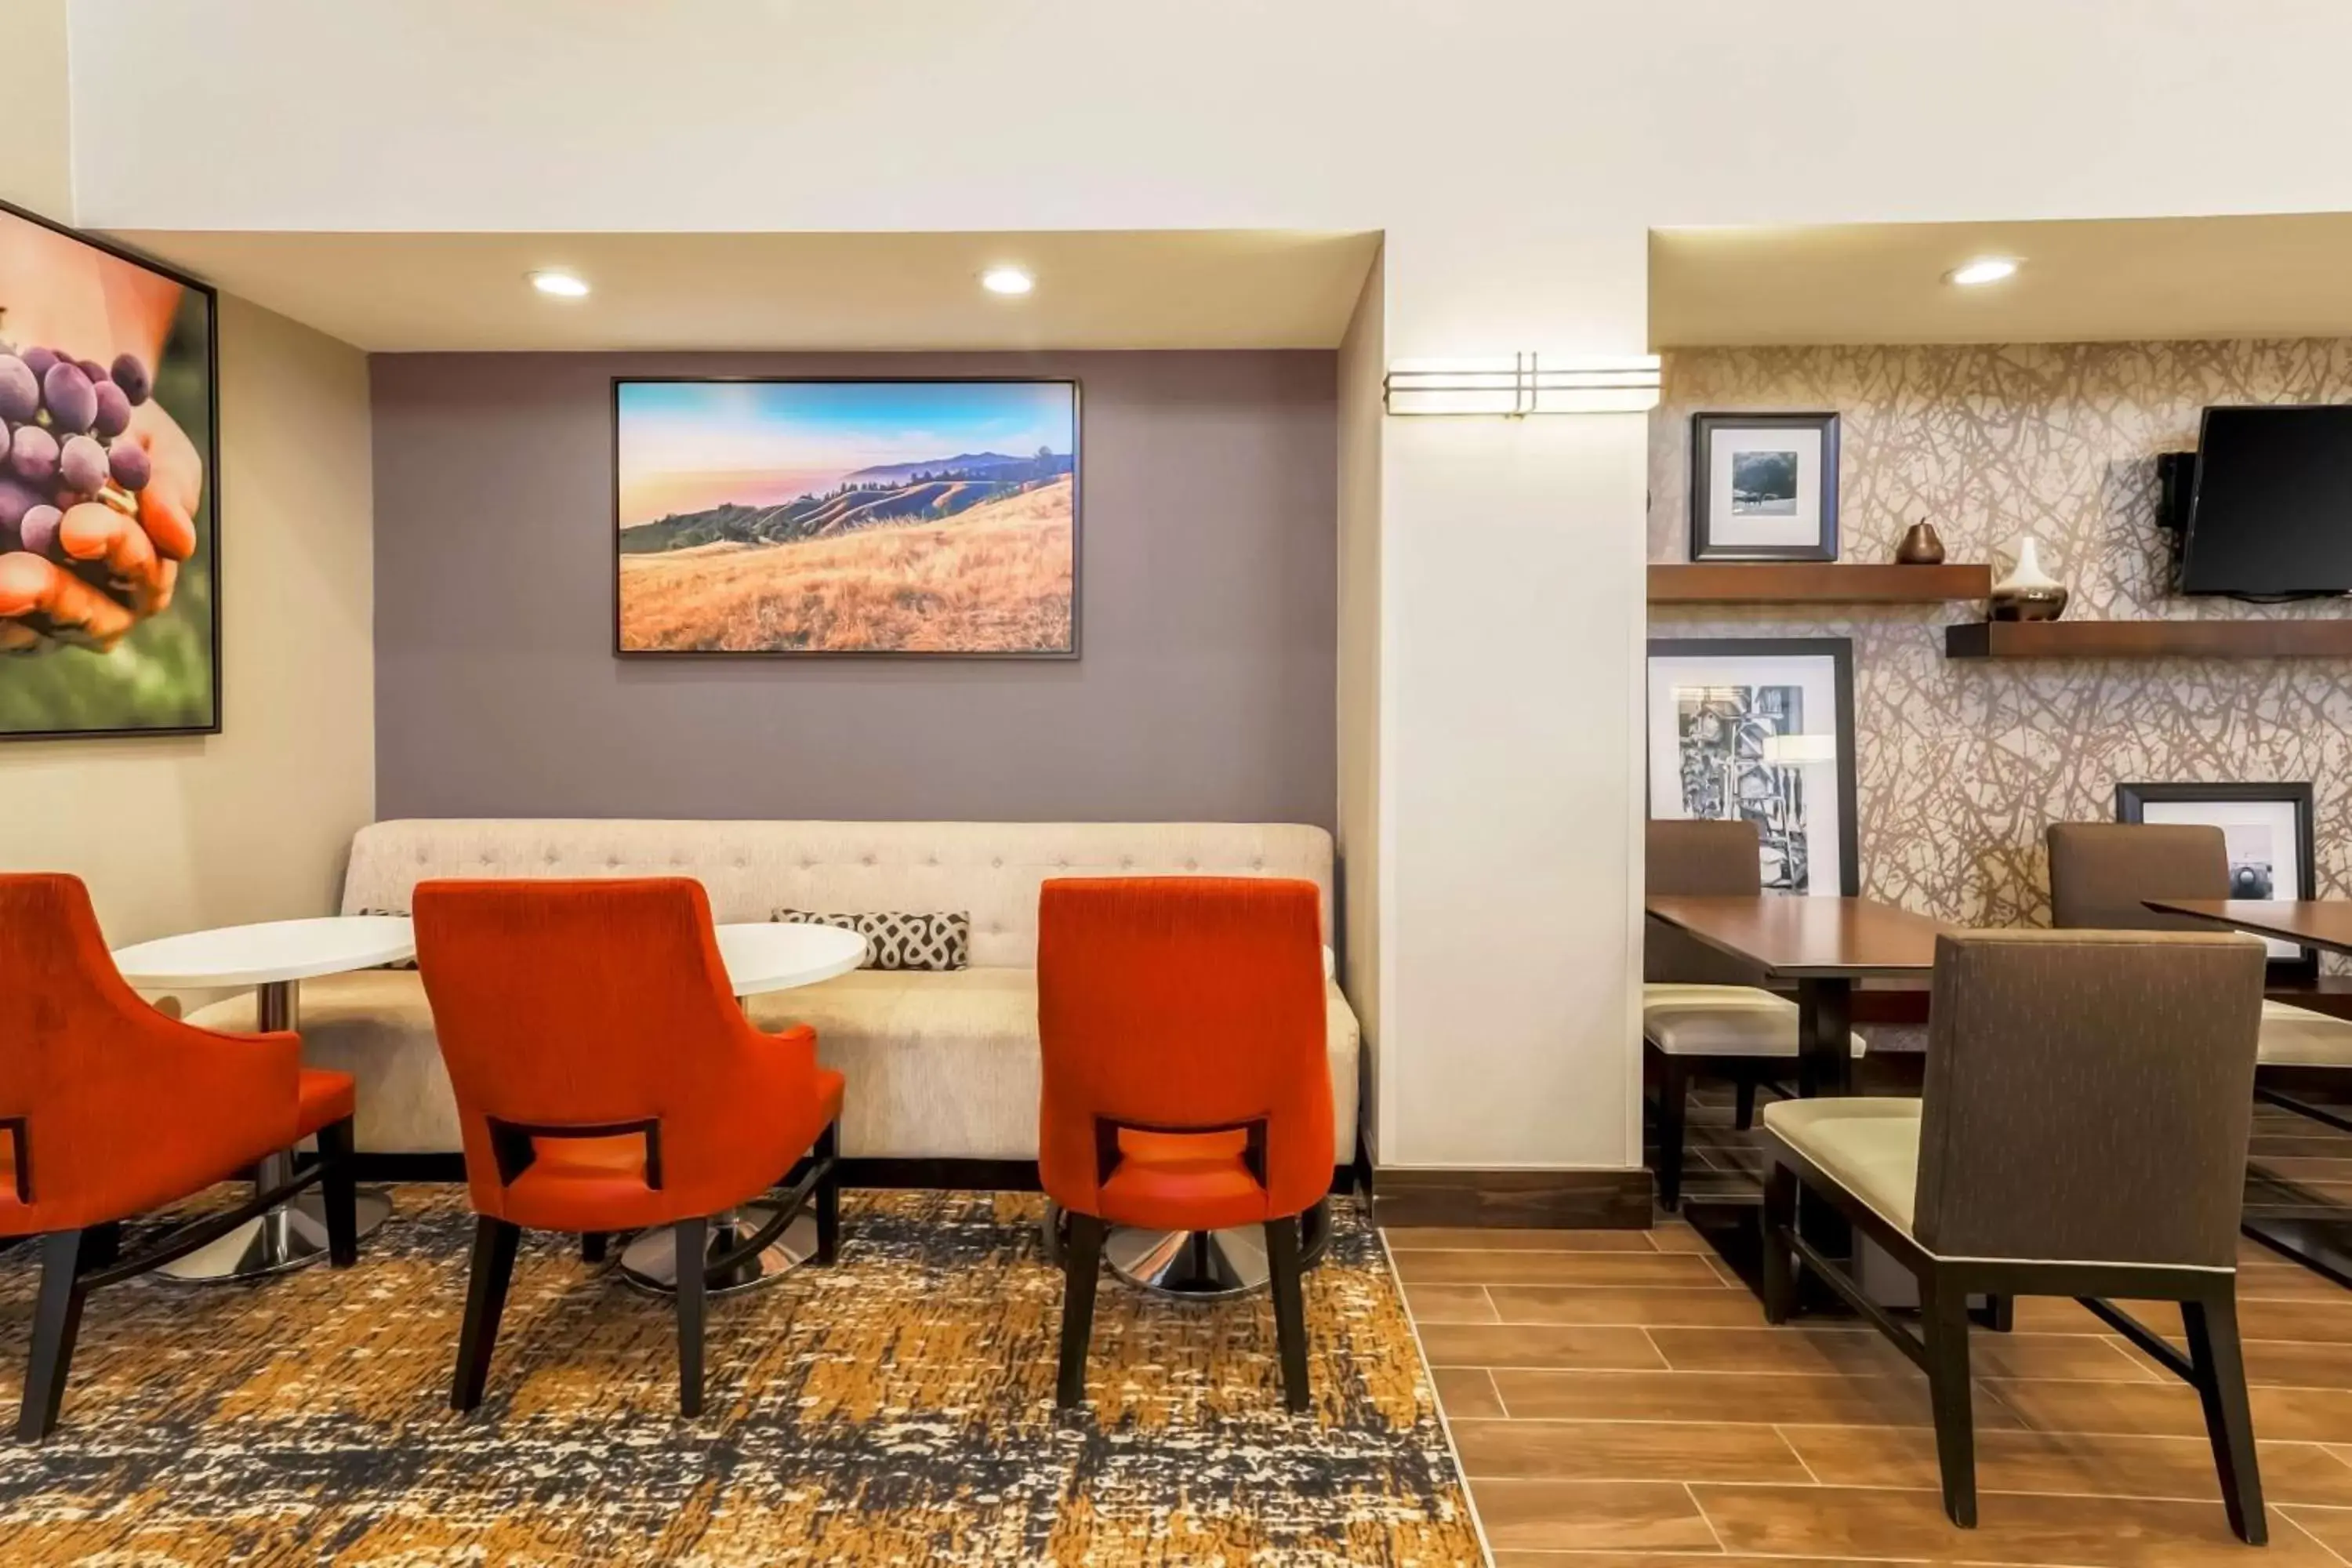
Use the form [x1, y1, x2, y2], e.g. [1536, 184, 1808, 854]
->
[115, 914, 416, 1283]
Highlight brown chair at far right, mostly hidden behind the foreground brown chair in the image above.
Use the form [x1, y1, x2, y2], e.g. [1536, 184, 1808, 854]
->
[2049, 822, 2352, 1100]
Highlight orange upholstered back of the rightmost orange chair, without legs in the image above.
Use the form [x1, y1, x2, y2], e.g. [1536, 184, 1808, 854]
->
[1037, 877, 1334, 1220]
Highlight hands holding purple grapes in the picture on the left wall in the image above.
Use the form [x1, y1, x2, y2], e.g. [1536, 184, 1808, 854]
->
[0, 343, 205, 652]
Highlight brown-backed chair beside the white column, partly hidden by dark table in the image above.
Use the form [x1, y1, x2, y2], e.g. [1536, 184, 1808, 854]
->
[1642, 820, 1863, 1208]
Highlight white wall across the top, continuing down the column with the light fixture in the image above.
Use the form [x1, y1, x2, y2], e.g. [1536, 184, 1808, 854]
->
[60, 0, 2352, 1166]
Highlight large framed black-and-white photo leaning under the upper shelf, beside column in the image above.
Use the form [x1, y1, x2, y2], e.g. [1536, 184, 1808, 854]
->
[1649, 637, 1860, 898]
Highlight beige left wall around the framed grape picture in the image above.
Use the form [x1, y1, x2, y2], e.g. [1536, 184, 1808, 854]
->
[0, 0, 376, 945]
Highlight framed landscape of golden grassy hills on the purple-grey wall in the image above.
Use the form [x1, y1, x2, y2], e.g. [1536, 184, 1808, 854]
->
[614, 379, 1080, 659]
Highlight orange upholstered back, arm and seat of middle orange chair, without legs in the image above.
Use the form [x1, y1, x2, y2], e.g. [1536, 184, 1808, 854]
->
[414, 877, 816, 1229]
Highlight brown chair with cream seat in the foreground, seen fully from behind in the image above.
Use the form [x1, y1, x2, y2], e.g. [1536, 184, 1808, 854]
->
[1764, 931, 2265, 1544]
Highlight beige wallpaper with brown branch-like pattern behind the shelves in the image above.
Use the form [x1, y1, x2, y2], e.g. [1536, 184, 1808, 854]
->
[1649, 341, 2352, 926]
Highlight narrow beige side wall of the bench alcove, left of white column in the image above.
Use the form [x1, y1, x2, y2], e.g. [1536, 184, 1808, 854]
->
[1338, 259, 1388, 1159]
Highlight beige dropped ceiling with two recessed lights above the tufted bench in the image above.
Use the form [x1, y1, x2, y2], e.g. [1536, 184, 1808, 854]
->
[113, 230, 1381, 353]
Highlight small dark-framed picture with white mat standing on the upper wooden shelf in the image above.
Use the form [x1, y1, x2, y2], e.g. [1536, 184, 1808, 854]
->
[1691, 414, 1837, 562]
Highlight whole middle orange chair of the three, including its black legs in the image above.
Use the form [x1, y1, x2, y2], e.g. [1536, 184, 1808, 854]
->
[414, 877, 842, 1415]
